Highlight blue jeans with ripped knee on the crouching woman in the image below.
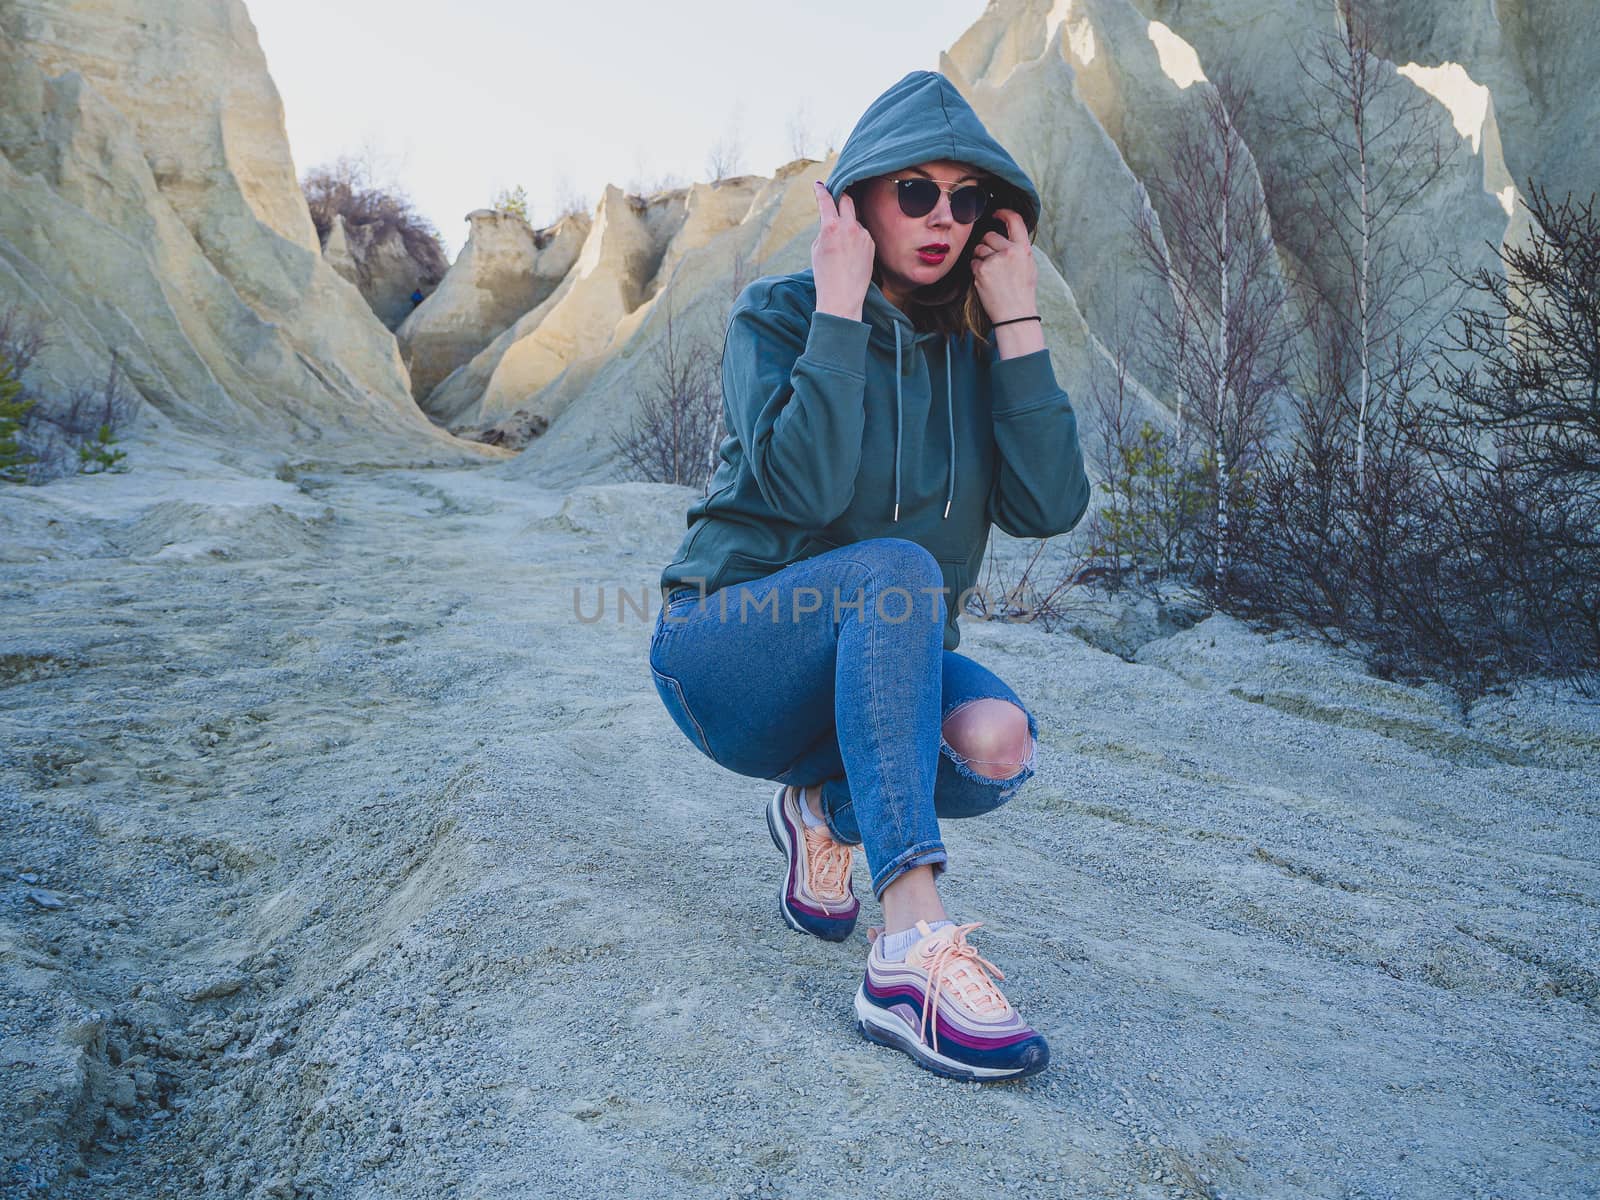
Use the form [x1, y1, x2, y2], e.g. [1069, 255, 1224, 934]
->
[650, 538, 1038, 901]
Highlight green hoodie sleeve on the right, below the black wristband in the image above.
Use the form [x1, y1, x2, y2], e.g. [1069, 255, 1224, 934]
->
[989, 349, 1090, 538]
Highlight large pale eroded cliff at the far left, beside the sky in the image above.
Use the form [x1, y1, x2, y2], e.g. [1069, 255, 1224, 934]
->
[0, 0, 488, 459]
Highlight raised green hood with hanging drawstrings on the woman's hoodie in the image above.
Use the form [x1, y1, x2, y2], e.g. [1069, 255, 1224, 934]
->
[824, 70, 1040, 520]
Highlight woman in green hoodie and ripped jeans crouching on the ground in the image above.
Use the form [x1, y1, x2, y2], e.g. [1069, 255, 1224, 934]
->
[650, 70, 1090, 1080]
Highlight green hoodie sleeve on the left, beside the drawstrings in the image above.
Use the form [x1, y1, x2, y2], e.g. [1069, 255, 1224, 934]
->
[722, 290, 870, 530]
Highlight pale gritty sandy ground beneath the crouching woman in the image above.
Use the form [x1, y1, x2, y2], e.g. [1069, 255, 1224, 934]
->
[0, 444, 1600, 1200]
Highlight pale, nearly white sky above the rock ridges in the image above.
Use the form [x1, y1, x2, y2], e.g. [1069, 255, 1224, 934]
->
[245, 0, 984, 258]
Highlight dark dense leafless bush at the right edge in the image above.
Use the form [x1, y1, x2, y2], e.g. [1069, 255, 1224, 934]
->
[1405, 179, 1600, 690]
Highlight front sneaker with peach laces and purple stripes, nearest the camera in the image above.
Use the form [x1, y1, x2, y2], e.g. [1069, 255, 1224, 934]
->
[856, 922, 1050, 1082]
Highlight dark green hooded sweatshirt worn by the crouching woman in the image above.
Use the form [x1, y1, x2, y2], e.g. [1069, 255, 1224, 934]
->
[661, 70, 1090, 650]
